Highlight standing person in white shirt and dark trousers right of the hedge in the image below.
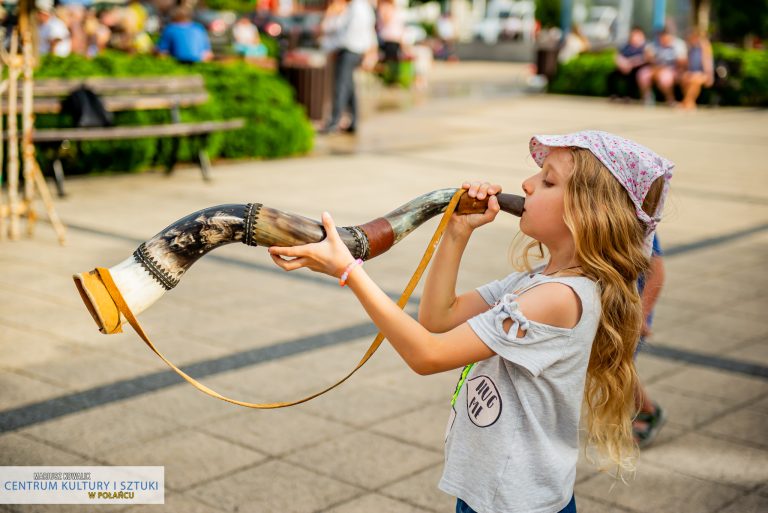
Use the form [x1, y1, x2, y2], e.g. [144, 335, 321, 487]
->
[320, 0, 376, 134]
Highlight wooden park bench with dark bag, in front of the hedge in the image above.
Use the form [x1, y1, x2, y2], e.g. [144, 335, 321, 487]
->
[2, 75, 245, 196]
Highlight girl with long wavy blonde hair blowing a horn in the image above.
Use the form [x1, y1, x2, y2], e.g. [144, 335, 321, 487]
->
[269, 132, 672, 513]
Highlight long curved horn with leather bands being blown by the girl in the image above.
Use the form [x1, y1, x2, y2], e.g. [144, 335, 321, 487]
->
[73, 189, 525, 333]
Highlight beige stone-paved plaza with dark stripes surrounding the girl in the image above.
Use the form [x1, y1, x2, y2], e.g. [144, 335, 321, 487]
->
[0, 64, 768, 513]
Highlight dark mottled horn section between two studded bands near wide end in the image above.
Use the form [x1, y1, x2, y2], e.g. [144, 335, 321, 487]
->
[134, 205, 247, 289]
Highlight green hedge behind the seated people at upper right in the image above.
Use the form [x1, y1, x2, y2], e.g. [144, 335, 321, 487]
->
[549, 43, 768, 107]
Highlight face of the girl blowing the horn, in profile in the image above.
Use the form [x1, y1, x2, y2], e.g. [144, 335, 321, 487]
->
[520, 148, 573, 247]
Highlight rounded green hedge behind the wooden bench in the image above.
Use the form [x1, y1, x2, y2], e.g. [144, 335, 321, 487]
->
[30, 52, 314, 173]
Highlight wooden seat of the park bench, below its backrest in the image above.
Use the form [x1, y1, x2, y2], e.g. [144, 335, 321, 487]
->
[32, 118, 245, 142]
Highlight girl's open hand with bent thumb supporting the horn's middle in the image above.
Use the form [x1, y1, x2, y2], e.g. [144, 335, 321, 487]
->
[269, 212, 355, 278]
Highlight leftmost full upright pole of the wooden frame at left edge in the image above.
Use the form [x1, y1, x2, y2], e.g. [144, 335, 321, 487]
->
[8, 29, 21, 240]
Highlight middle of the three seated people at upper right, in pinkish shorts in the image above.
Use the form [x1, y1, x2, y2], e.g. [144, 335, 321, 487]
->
[638, 29, 687, 105]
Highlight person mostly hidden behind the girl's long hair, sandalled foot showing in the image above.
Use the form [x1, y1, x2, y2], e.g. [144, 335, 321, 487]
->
[632, 235, 667, 449]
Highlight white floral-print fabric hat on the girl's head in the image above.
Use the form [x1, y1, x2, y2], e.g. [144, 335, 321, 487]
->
[529, 130, 675, 255]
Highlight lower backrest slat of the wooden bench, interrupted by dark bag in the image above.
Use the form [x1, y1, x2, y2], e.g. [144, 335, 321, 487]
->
[2, 91, 209, 114]
